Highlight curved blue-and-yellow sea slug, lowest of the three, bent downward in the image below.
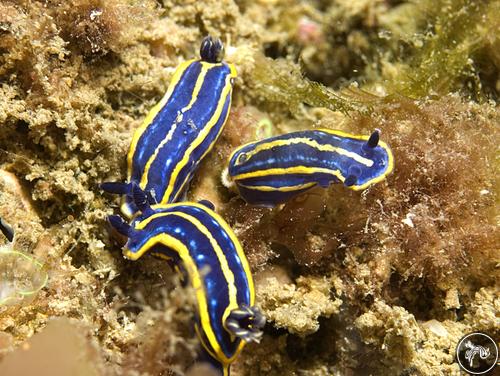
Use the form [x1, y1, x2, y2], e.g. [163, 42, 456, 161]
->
[109, 184, 265, 375]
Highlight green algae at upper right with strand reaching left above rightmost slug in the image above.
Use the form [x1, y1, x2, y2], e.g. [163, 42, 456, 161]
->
[252, 0, 500, 115]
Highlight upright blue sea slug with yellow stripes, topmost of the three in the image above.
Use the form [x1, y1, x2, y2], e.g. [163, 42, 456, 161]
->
[101, 37, 236, 218]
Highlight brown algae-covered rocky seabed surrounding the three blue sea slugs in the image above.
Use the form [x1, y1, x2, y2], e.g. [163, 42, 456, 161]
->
[0, 0, 500, 376]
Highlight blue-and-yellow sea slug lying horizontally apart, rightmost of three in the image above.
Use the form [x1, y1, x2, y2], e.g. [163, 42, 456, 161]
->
[223, 129, 394, 207]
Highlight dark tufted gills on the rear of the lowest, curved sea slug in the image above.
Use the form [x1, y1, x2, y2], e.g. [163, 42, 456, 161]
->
[225, 304, 266, 343]
